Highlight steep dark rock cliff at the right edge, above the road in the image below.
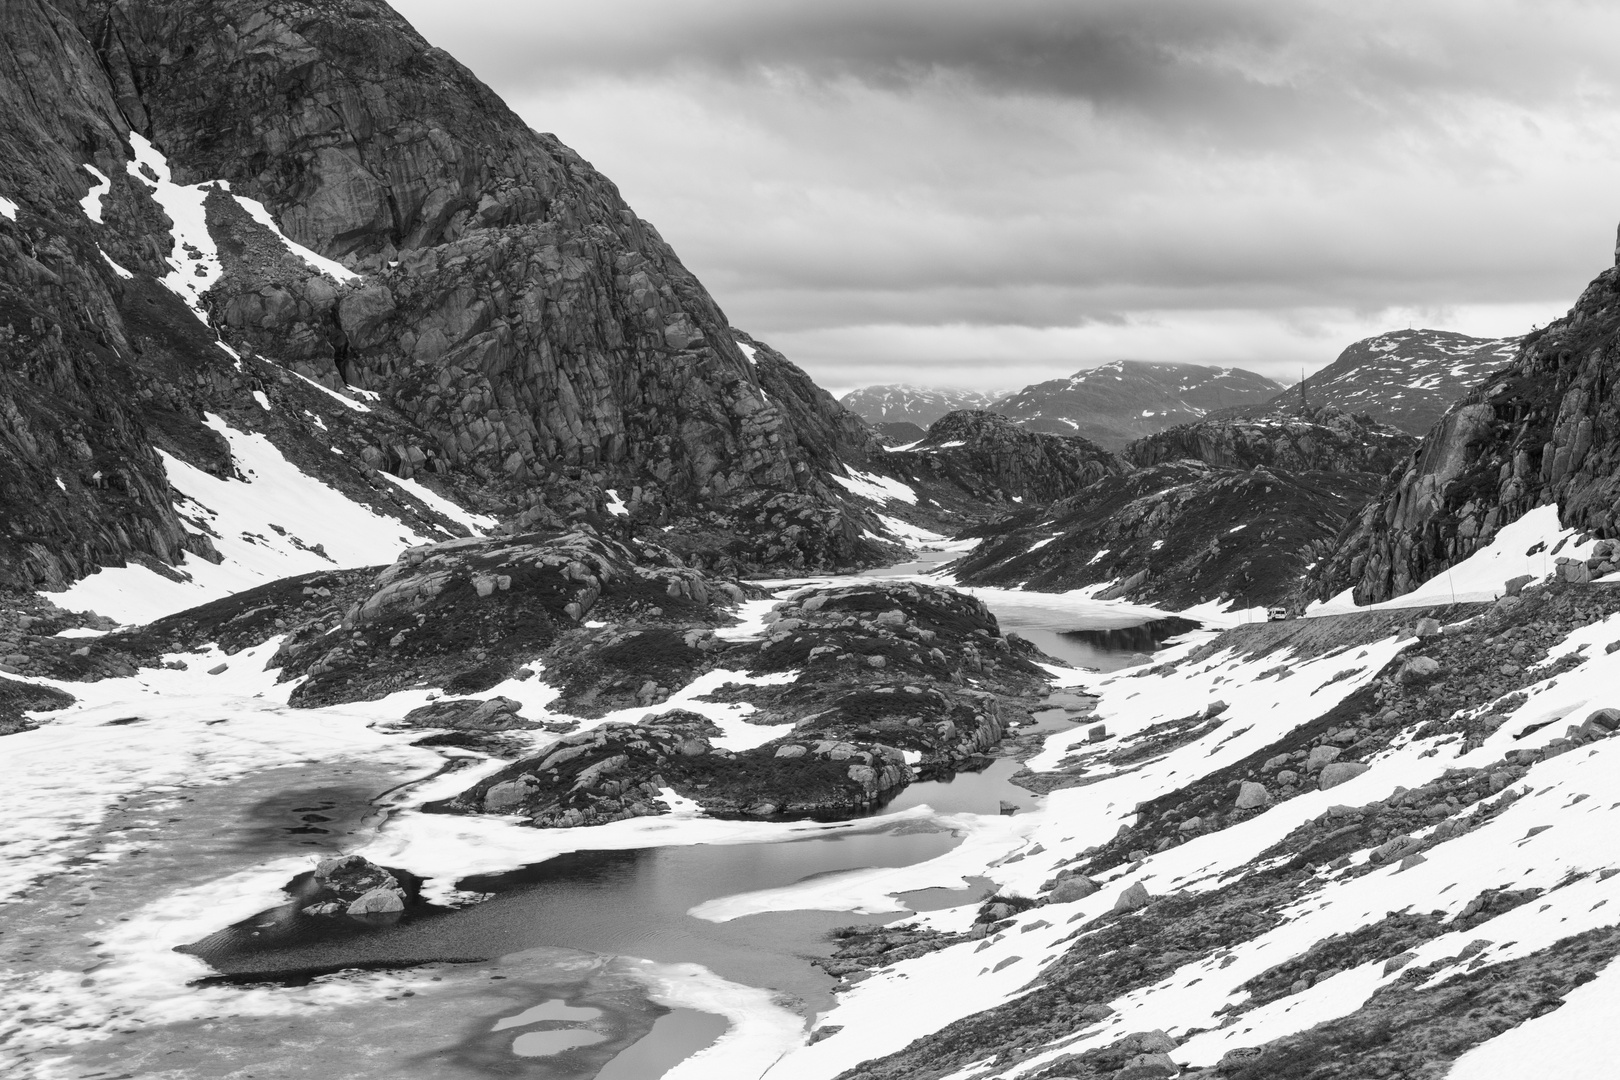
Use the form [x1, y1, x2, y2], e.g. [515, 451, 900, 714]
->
[1309, 259, 1620, 602]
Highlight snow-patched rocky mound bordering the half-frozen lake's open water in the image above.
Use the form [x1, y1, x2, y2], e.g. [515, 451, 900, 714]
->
[436, 583, 1045, 827]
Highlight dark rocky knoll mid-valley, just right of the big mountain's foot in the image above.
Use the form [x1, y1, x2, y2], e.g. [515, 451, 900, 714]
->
[880, 413, 1131, 517]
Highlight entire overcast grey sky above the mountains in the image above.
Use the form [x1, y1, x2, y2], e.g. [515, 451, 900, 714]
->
[395, 0, 1620, 390]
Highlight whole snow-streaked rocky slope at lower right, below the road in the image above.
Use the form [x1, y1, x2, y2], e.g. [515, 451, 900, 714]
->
[761, 508, 1620, 1080]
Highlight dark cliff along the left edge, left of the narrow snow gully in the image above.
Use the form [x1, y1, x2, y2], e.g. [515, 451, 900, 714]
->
[0, 0, 224, 585]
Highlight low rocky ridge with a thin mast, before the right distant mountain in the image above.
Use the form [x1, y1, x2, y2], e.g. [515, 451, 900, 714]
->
[1124, 408, 1418, 476]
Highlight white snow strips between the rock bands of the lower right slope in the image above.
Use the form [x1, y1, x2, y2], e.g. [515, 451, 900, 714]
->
[761, 592, 1620, 1080]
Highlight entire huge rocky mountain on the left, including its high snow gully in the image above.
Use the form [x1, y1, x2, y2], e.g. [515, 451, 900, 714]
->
[0, 0, 870, 588]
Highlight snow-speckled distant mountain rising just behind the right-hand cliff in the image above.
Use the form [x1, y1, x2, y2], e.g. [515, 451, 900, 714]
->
[1223, 330, 1521, 436]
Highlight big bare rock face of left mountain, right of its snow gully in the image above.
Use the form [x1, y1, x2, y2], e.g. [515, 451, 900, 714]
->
[78, 0, 861, 499]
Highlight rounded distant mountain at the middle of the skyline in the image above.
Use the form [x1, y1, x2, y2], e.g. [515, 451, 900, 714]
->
[990, 359, 1281, 450]
